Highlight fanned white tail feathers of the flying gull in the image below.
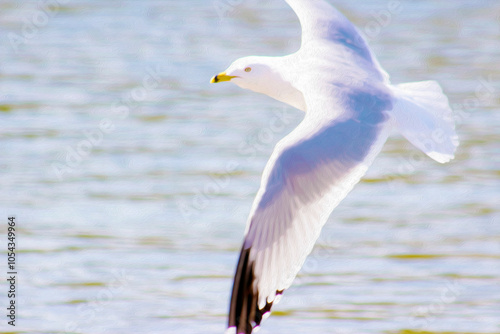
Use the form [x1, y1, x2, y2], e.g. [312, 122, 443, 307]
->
[391, 81, 458, 163]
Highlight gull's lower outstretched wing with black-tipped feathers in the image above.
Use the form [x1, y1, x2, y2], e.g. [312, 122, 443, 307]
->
[228, 84, 392, 333]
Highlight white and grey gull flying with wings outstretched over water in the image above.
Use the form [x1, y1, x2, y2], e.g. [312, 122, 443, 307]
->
[210, 0, 458, 334]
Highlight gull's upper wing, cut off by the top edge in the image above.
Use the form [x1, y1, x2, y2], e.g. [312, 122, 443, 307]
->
[286, 0, 389, 81]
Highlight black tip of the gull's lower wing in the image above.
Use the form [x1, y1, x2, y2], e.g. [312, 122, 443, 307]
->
[228, 246, 284, 334]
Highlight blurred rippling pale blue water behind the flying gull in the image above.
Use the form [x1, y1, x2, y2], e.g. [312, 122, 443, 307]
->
[0, 0, 500, 334]
